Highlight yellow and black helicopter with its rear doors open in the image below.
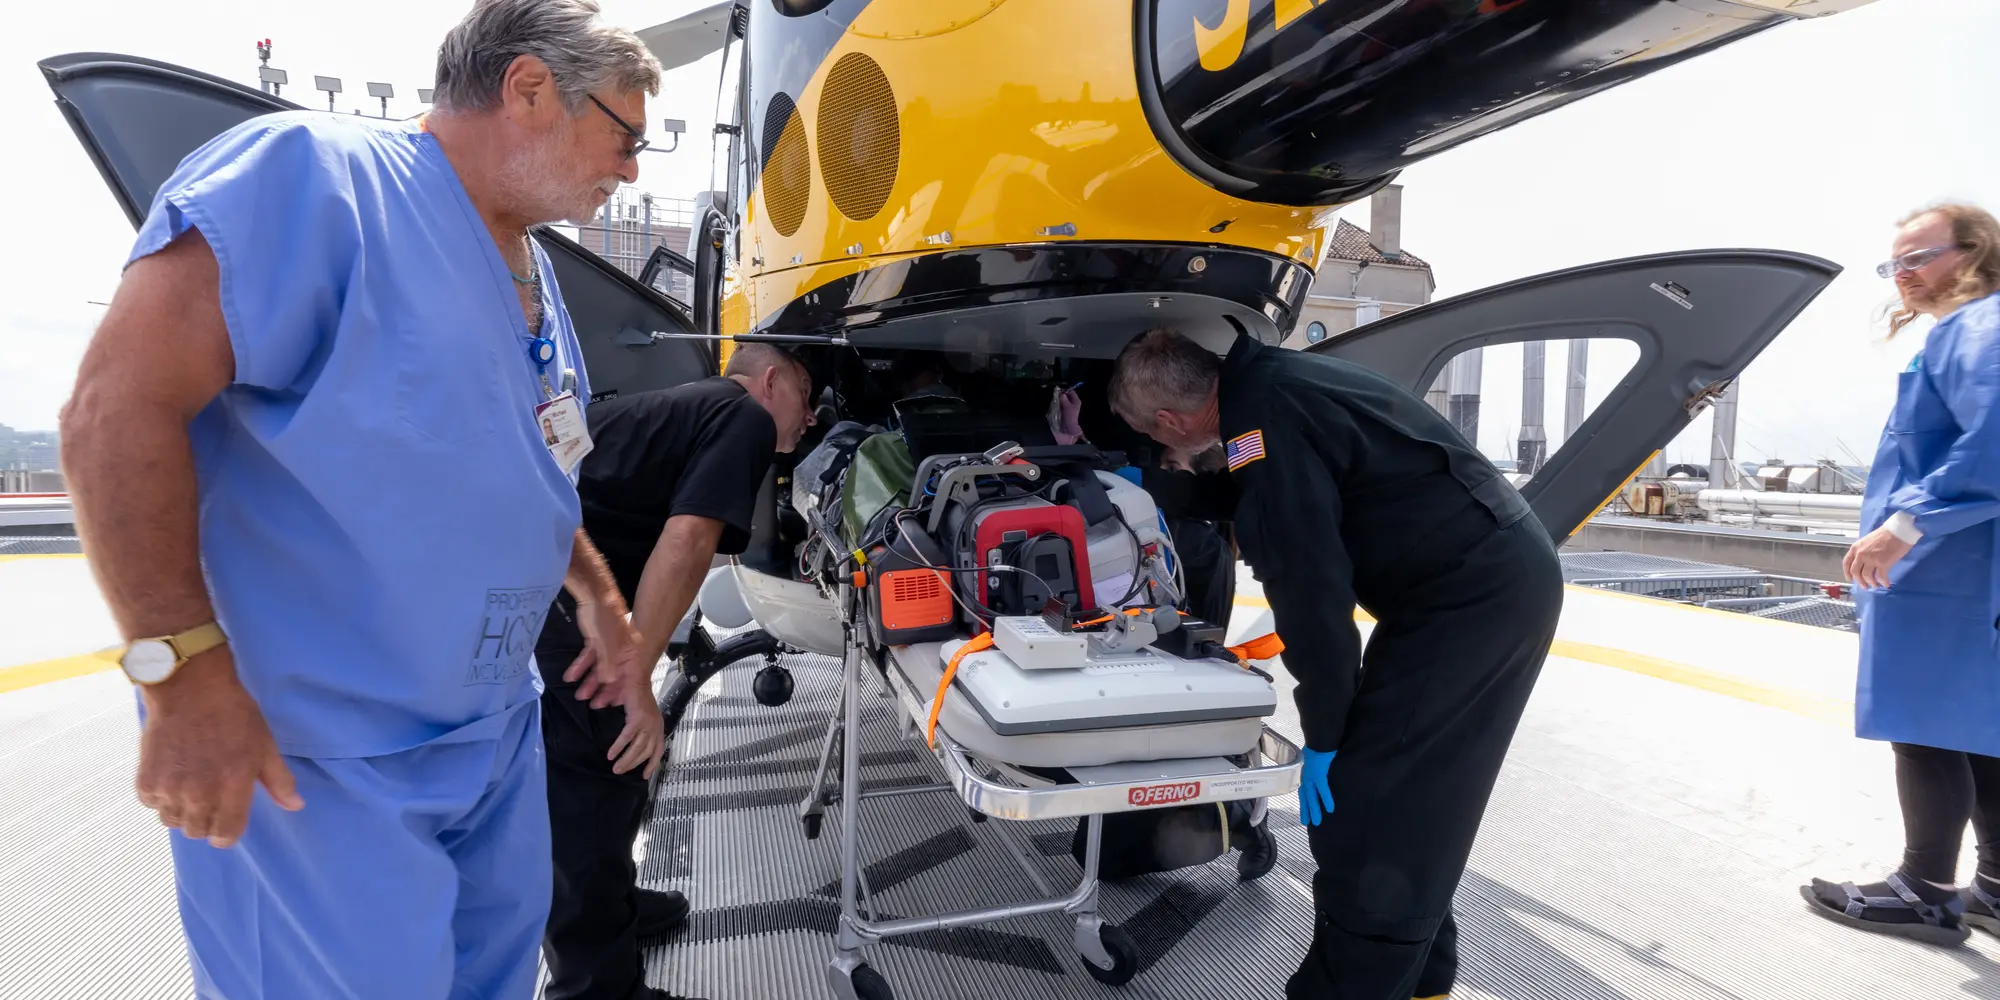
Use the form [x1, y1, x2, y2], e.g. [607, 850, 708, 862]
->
[40, 0, 1872, 588]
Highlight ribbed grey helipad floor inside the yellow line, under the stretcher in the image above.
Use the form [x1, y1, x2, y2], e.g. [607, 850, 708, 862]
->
[0, 636, 2000, 1000]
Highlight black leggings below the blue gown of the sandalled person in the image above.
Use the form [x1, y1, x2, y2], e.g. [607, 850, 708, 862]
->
[1892, 744, 2000, 886]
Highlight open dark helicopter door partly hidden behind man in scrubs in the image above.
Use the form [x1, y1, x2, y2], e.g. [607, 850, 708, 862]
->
[40, 52, 716, 396]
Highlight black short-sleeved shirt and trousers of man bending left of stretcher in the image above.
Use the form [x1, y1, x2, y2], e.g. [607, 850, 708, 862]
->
[534, 376, 778, 1000]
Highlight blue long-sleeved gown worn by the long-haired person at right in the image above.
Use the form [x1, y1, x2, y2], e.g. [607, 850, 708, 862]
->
[1854, 294, 2000, 756]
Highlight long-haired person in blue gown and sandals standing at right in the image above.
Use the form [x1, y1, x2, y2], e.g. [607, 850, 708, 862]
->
[1802, 204, 2000, 944]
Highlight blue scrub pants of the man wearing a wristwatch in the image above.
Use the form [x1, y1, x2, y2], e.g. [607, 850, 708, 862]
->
[172, 702, 552, 1000]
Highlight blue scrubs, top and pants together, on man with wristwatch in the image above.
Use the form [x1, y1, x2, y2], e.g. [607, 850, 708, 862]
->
[132, 112, 588, 1000]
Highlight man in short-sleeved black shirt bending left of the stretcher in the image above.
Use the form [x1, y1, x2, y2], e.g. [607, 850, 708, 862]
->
[534, 344, 812, 1000]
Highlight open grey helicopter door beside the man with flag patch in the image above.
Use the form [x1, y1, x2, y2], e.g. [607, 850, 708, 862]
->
[1306, 250, 1840, 544]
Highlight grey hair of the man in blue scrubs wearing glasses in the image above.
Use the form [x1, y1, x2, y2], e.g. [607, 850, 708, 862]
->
[432, 0, 660, 114]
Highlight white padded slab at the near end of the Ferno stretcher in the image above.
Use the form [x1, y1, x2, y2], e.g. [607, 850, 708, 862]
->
[938, 630, 1278, 736]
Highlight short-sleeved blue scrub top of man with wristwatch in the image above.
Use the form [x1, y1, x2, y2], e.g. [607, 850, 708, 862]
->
[132, 112, 590, 758]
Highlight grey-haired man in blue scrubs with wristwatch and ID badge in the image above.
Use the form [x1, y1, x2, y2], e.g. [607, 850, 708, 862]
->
[62, 0, 660, 1000]
